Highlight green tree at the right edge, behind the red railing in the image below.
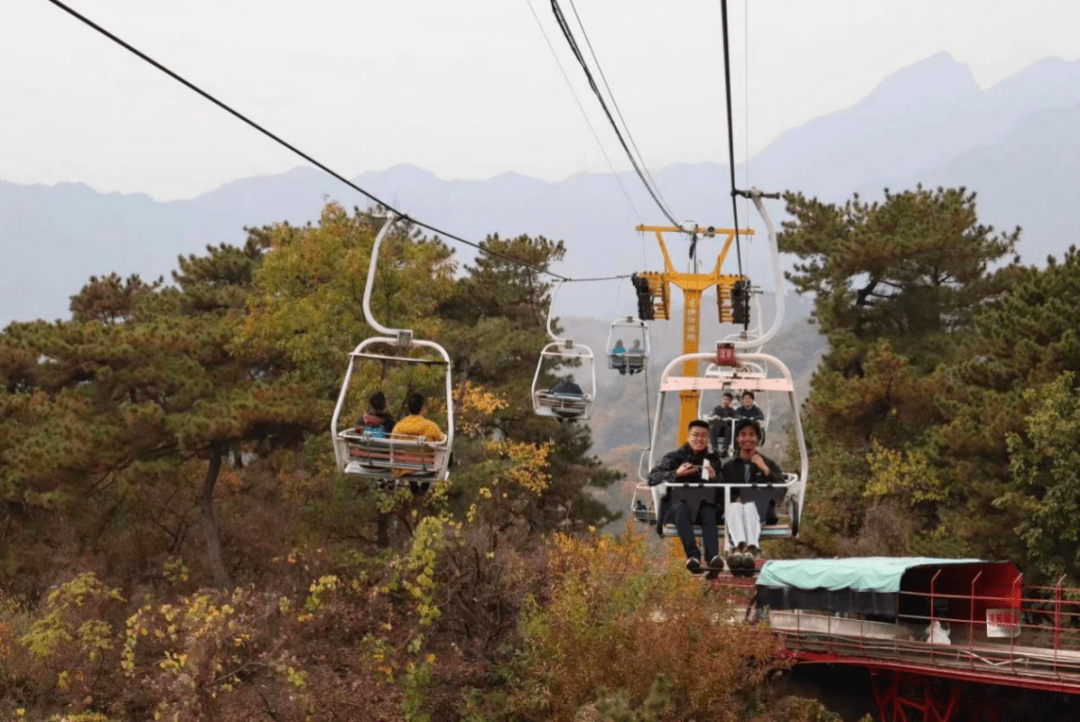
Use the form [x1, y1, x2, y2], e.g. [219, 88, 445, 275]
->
[931, 247, 1080, 573]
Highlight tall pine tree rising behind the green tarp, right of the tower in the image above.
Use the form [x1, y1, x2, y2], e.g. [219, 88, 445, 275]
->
[780, 187, 1023, 553]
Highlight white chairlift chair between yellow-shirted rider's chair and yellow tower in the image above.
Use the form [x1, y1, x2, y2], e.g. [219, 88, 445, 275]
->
[531, 283, 596, 421]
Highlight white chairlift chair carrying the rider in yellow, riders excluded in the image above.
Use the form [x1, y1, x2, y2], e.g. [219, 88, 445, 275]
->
[330, 216, 454, 486]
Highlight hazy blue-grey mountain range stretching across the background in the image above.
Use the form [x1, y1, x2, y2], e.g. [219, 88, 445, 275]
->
[0, 54, 1080, 326]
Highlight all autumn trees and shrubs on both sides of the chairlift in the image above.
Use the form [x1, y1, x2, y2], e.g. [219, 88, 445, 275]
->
[0, 188, 1080, 722]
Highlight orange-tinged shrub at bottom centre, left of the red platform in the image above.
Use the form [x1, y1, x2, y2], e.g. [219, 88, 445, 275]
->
[511, 534, 783, 721]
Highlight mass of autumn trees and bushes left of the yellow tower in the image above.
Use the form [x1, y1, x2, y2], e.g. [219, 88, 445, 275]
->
[0, 204, 833, 722]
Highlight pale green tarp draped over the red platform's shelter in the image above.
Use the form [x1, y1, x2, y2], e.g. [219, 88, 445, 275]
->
[757, 557, 982, 594]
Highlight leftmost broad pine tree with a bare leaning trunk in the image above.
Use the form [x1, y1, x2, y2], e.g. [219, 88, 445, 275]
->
[3, 237, 322, 587]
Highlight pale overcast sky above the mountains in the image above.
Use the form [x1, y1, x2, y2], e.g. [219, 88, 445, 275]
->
[6, 0, 1080, 201]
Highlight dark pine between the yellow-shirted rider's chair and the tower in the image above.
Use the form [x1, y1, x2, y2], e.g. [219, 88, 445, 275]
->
[440, 235, 619, 531]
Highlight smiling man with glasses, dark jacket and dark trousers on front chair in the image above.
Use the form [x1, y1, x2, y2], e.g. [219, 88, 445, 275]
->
[649, 419, 724, 574]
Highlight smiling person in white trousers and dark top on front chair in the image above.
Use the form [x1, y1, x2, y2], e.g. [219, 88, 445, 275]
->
[723, 419, 783, 571]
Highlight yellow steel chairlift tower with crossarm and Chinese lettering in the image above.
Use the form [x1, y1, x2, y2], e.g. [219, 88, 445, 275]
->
[635, 226, 754, 444]
